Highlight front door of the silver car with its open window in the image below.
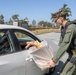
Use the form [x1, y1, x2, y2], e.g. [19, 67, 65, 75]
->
[13, 30, 43, 75]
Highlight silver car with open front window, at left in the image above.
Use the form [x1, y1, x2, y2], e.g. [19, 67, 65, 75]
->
[0, 24, 57, 75]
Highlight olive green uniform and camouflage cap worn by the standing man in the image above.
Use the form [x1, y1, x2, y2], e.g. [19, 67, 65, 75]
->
[52, 10, 76, 75]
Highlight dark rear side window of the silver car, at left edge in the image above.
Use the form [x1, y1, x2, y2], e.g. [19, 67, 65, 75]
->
[0, 32, 12, 55]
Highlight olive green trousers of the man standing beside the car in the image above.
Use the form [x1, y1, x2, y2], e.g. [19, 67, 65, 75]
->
[60, 55, 76, 75]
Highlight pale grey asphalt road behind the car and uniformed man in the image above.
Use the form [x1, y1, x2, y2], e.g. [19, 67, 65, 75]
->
[38, 32, 68, 75]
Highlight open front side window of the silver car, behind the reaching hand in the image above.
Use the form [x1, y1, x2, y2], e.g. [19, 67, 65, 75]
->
[14, 31, 34, 50]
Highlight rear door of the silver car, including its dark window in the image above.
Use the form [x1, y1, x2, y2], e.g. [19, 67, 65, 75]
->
[0, 30, 26, 75]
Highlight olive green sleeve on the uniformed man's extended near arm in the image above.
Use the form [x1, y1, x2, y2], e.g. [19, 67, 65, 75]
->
[52, 25, 75, 63]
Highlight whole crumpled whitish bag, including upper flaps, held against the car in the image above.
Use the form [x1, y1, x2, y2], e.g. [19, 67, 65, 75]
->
[30, 41, 53, 70]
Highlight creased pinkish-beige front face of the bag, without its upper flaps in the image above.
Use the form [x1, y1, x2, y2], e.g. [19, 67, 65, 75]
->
[31, 48, 51, 70]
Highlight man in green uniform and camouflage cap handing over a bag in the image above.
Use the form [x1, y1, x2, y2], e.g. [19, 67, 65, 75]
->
[49, 6, 76, 75]
